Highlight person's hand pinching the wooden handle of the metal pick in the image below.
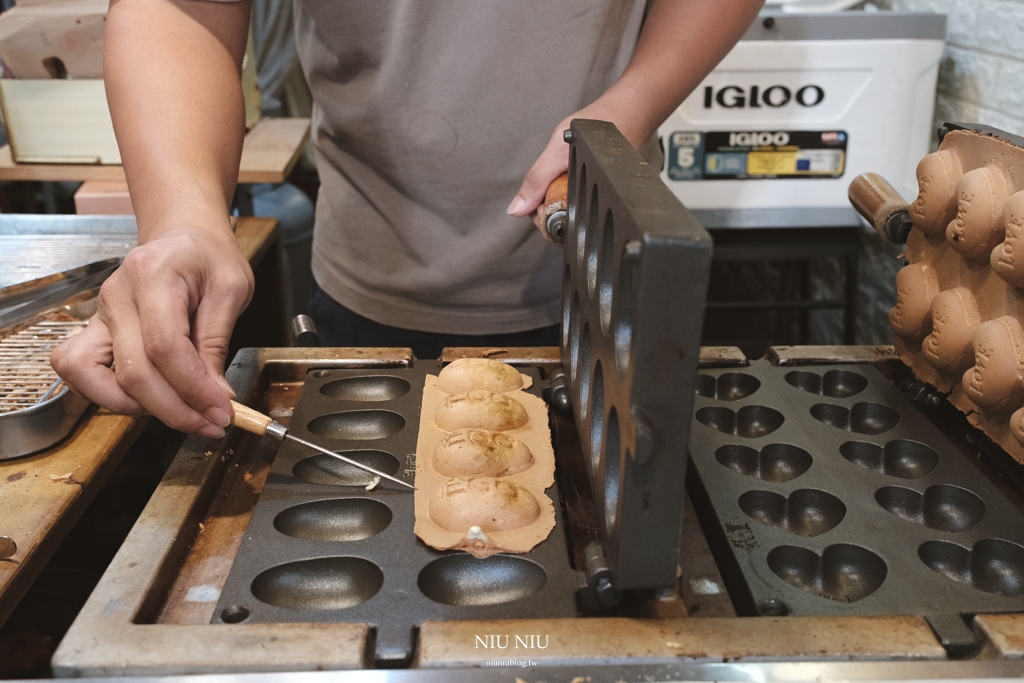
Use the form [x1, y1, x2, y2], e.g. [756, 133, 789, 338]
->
[50, 229, 253, 438]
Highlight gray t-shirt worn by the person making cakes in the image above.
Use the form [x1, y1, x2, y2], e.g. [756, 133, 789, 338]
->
[295, 0, 645, 334]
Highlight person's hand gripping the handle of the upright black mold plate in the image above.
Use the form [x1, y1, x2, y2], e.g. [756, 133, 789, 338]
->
[508, 92, 650, 232]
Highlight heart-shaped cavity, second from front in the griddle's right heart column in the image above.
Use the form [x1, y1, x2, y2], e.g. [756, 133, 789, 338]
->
[874, 483, 985, 531]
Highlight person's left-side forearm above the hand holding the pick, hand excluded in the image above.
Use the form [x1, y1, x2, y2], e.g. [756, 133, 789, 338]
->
[103, 0, 250, 244]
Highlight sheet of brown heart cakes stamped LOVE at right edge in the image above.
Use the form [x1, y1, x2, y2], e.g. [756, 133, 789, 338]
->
[889, 130, 1024, 463]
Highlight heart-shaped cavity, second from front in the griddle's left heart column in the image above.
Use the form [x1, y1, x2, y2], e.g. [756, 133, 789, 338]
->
[739, 488, 846, 537]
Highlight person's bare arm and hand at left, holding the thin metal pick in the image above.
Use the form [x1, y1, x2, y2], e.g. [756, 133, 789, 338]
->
[51, 0, 253, 437]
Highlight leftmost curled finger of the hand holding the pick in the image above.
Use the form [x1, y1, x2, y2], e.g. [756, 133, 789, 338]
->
[50, 317, 145, 415]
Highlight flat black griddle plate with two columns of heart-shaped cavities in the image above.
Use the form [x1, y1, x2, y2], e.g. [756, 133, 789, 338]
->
[690, 360, 1024, 615]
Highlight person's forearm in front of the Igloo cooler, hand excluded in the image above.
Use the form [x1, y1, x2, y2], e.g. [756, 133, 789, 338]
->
[601, 0, 764, 146]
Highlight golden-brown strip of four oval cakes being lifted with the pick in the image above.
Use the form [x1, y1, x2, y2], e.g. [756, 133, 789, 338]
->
[415, 358, 555, 558]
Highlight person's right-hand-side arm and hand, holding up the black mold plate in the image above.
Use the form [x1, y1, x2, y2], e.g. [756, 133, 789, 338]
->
[508, 0, 764, 222]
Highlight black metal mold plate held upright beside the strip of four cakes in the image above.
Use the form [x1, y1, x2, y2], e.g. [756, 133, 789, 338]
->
[561, 120, 712, 589]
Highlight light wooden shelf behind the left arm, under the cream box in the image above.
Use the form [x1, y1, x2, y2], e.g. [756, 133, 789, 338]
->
[0, 119, 309, 183]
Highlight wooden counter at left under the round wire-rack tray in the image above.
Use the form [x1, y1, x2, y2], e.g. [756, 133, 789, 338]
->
[0, 218, 284, 625]
